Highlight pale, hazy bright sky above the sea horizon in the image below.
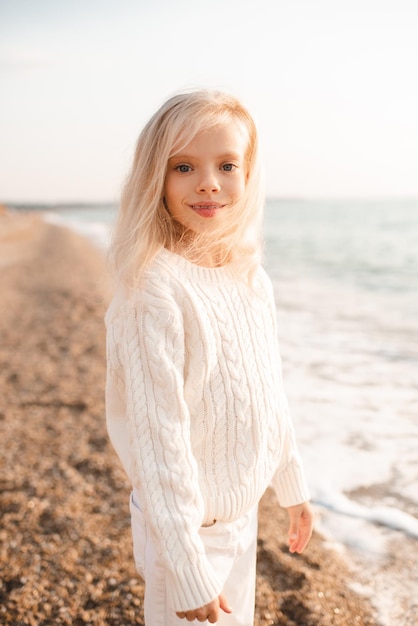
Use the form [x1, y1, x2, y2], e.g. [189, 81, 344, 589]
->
[0, 0, 418, 203]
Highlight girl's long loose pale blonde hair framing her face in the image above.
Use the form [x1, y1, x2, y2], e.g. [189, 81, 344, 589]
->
[110, 90, 264, 287]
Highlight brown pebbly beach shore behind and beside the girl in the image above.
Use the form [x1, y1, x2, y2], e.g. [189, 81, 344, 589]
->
[0, 211, 378, 626]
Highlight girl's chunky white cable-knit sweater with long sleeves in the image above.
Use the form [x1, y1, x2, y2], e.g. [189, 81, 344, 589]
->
[106, 249, 309, 611]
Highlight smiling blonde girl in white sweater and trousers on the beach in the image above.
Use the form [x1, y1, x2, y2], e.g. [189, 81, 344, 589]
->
[106, 91, 312, 626]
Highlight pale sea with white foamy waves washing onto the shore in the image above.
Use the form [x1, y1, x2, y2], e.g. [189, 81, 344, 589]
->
[27, 198, 418, 626]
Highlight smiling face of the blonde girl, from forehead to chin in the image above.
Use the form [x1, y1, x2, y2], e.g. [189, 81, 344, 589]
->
[164, 122, 248, 233]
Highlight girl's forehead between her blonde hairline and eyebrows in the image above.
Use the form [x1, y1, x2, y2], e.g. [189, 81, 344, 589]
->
[170, 120, 249, 158]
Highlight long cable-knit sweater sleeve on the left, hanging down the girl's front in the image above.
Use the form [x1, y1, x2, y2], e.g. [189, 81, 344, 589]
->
[122, 287, 221, 611]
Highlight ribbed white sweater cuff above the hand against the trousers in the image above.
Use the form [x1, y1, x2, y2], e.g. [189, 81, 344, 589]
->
[167, 556, 222, 612]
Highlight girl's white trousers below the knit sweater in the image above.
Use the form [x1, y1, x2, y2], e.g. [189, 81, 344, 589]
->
[130, 492, 257, 626]
